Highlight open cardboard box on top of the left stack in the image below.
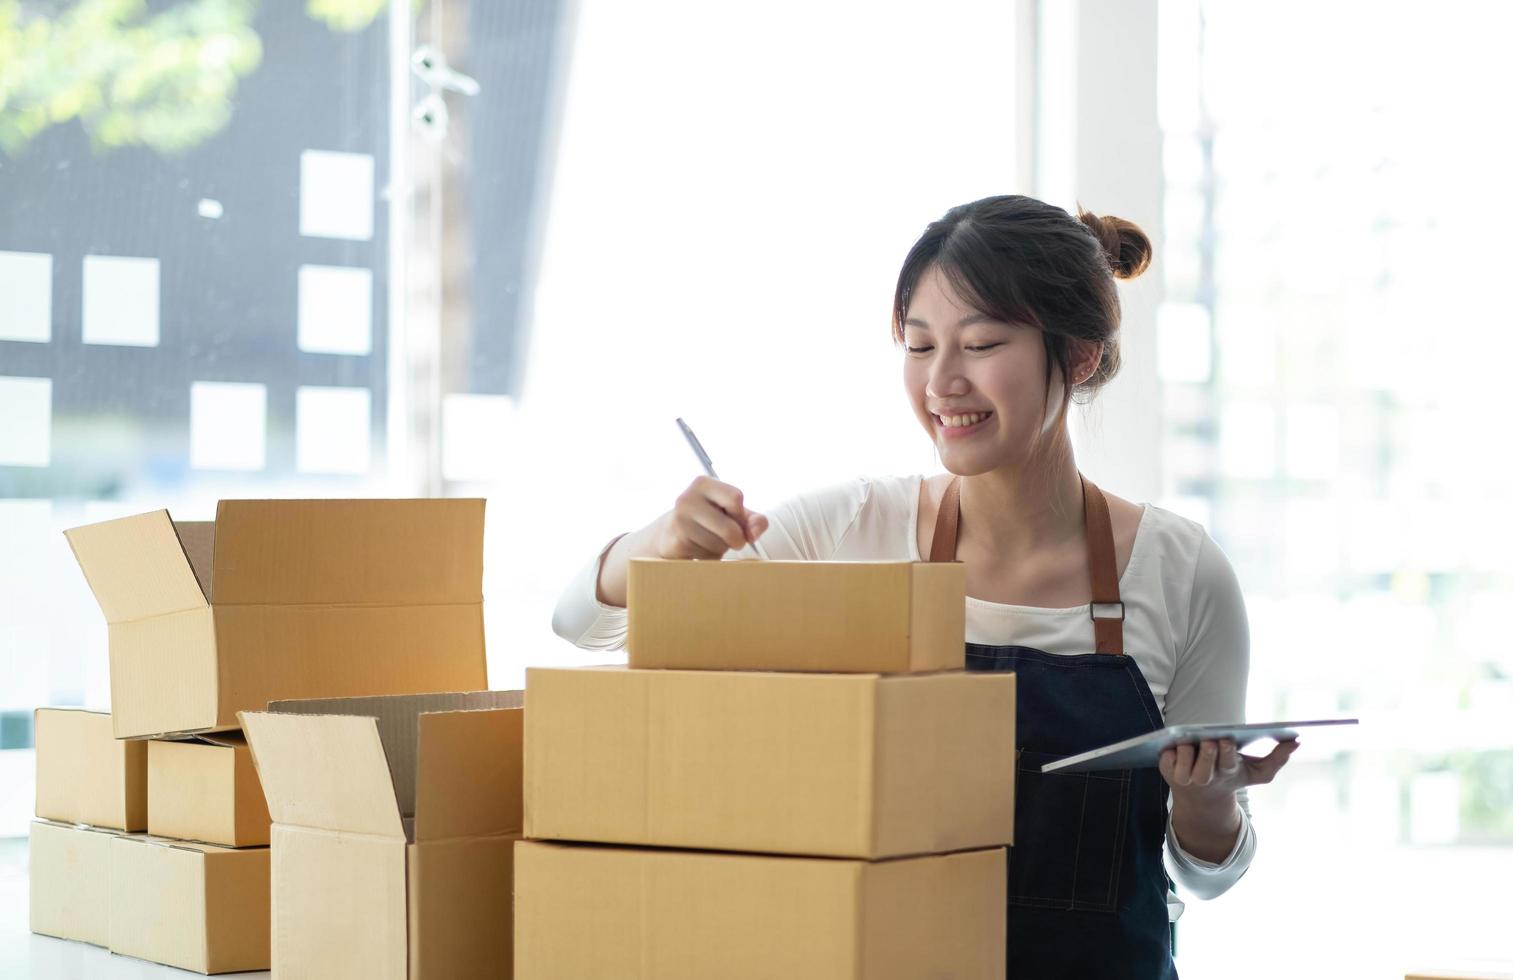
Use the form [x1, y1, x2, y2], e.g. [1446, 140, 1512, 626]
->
[67, 499, 487, 738]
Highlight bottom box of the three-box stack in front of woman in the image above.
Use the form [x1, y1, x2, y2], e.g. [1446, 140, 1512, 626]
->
[514, 834, 1008, 980]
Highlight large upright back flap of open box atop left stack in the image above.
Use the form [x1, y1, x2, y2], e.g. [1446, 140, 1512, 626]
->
[210, 499, 484, 605]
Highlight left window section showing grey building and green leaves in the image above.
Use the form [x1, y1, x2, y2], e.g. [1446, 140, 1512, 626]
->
[0, 0, 569, 835]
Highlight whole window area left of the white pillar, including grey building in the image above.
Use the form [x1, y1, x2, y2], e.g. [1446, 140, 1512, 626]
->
[0, 0, 1020, 833]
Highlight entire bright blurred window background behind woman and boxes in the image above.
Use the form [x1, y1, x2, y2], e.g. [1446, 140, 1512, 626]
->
[0, 0, 1513, 977]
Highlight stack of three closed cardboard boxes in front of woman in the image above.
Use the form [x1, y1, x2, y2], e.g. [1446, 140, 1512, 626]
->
[514, 560, 1015, 980]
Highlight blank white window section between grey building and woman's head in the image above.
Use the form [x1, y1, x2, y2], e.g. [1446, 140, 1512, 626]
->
[496, 0, 1017, 685]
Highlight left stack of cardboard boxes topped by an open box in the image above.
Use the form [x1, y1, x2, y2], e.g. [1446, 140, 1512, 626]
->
[32, 501, 486, 974]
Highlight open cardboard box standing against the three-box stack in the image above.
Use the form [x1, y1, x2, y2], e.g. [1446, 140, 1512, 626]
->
[242, 691, 525, 980]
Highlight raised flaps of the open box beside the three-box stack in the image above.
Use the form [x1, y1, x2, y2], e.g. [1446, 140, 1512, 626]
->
[241, 691, 525, 839]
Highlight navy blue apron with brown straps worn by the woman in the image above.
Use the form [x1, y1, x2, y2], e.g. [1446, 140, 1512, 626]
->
[930, 479, 1177, 980]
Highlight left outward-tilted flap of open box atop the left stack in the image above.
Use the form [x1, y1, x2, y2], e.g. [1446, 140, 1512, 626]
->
[64, 510, 209, 623]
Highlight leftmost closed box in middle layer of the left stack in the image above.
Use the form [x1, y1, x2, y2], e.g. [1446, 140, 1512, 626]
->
[33, 708, 147, 830]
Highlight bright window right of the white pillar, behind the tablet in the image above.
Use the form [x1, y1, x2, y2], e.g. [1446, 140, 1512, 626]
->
[1159, 0, 1513, 977]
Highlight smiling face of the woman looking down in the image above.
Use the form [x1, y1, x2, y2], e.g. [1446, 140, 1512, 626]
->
[903, 266, 1061, 476]
